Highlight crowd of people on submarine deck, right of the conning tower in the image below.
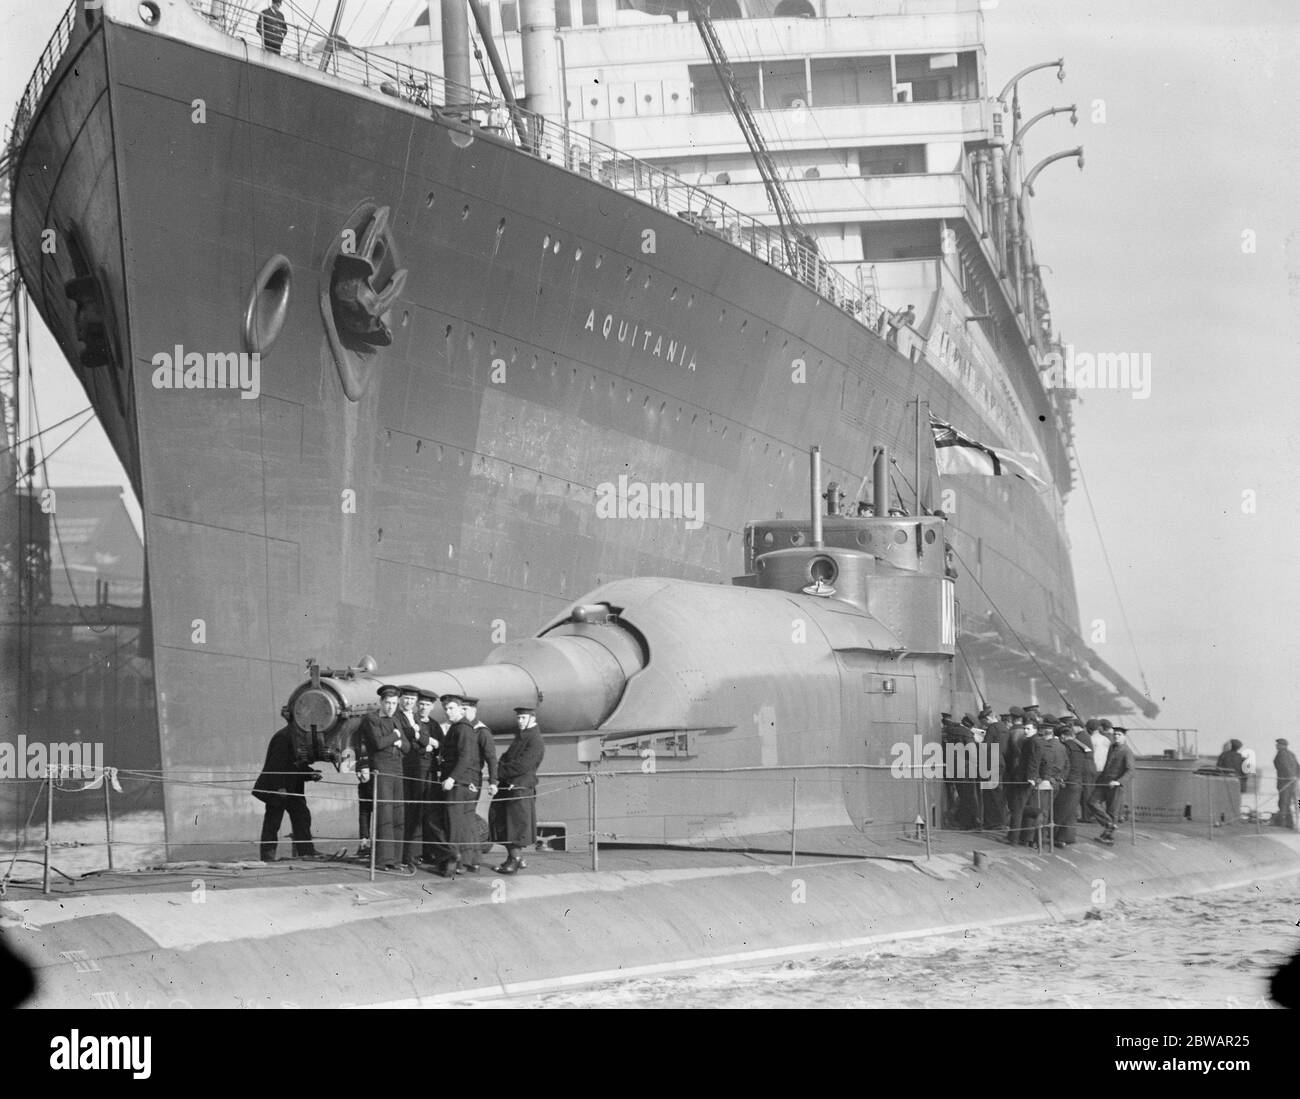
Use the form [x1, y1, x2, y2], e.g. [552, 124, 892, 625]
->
[941, 704, 1134, 848]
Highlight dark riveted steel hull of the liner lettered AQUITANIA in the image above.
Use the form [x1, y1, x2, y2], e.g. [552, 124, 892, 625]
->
[14, 5, 1078, 851]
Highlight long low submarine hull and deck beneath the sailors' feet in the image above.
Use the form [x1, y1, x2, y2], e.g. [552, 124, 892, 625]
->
[0, 823, 1300, 1007]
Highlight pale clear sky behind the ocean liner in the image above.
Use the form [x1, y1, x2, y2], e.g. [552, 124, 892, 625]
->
[0, 0, 1300, 763]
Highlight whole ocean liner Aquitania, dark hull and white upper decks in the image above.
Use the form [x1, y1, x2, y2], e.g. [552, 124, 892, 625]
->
[13, 0, 1149, 849]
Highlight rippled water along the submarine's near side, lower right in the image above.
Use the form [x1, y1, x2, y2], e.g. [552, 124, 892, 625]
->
[495, 878, 1300, 1009]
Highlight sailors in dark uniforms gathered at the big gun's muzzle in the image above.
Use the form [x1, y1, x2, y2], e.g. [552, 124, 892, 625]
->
[254, 684, 546, 878]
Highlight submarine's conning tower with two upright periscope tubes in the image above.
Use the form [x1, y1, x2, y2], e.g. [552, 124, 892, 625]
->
[732, 447, 957, 654]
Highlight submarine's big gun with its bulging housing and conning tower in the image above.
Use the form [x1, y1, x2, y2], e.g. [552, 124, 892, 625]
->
[290, 449, 956, 841]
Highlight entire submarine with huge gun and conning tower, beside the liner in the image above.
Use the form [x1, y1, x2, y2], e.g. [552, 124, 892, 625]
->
[0, 447, 1300, 1009]
